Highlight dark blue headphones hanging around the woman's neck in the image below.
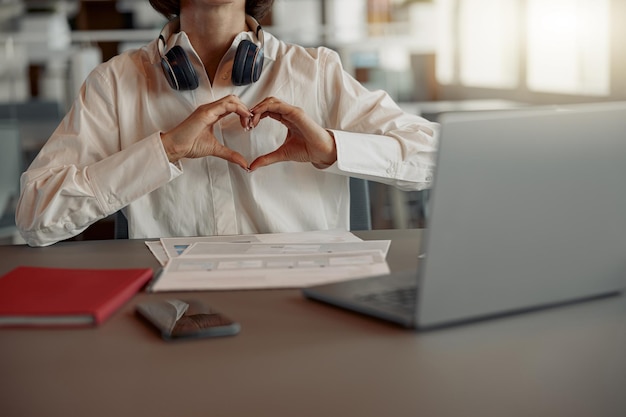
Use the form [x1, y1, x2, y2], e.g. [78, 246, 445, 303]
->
[158, 16, 265, 90]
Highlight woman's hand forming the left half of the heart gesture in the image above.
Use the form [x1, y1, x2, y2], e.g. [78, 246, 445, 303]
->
[161, 95, 252, 170]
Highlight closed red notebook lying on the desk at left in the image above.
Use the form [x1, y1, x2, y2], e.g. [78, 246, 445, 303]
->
[0, 266, 152, 326]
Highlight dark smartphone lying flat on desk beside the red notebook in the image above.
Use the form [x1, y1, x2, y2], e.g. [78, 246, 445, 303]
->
[136, 299, 241, 340]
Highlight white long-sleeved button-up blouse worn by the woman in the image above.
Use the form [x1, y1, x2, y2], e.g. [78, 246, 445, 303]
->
[16, 19, 438, 246]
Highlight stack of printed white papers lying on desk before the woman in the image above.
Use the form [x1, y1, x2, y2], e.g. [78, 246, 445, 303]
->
[146, 231, 391, 291]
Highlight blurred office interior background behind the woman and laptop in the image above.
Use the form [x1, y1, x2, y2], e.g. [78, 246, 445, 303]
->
[0, 0, 626, 242]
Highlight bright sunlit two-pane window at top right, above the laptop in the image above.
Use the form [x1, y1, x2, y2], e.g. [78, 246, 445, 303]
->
[437, 0, 610, 95]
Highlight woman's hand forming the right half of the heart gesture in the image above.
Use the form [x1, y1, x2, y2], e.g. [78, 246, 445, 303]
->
[250, 97, 337, 171]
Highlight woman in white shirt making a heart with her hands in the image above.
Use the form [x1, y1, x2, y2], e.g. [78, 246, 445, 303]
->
[16, 0, 437, 246]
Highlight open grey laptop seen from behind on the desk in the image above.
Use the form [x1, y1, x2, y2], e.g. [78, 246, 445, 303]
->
[303, 102, 626, 329]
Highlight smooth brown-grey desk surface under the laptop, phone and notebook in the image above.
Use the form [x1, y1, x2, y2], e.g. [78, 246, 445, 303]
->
[0, 230, 626, 417]
